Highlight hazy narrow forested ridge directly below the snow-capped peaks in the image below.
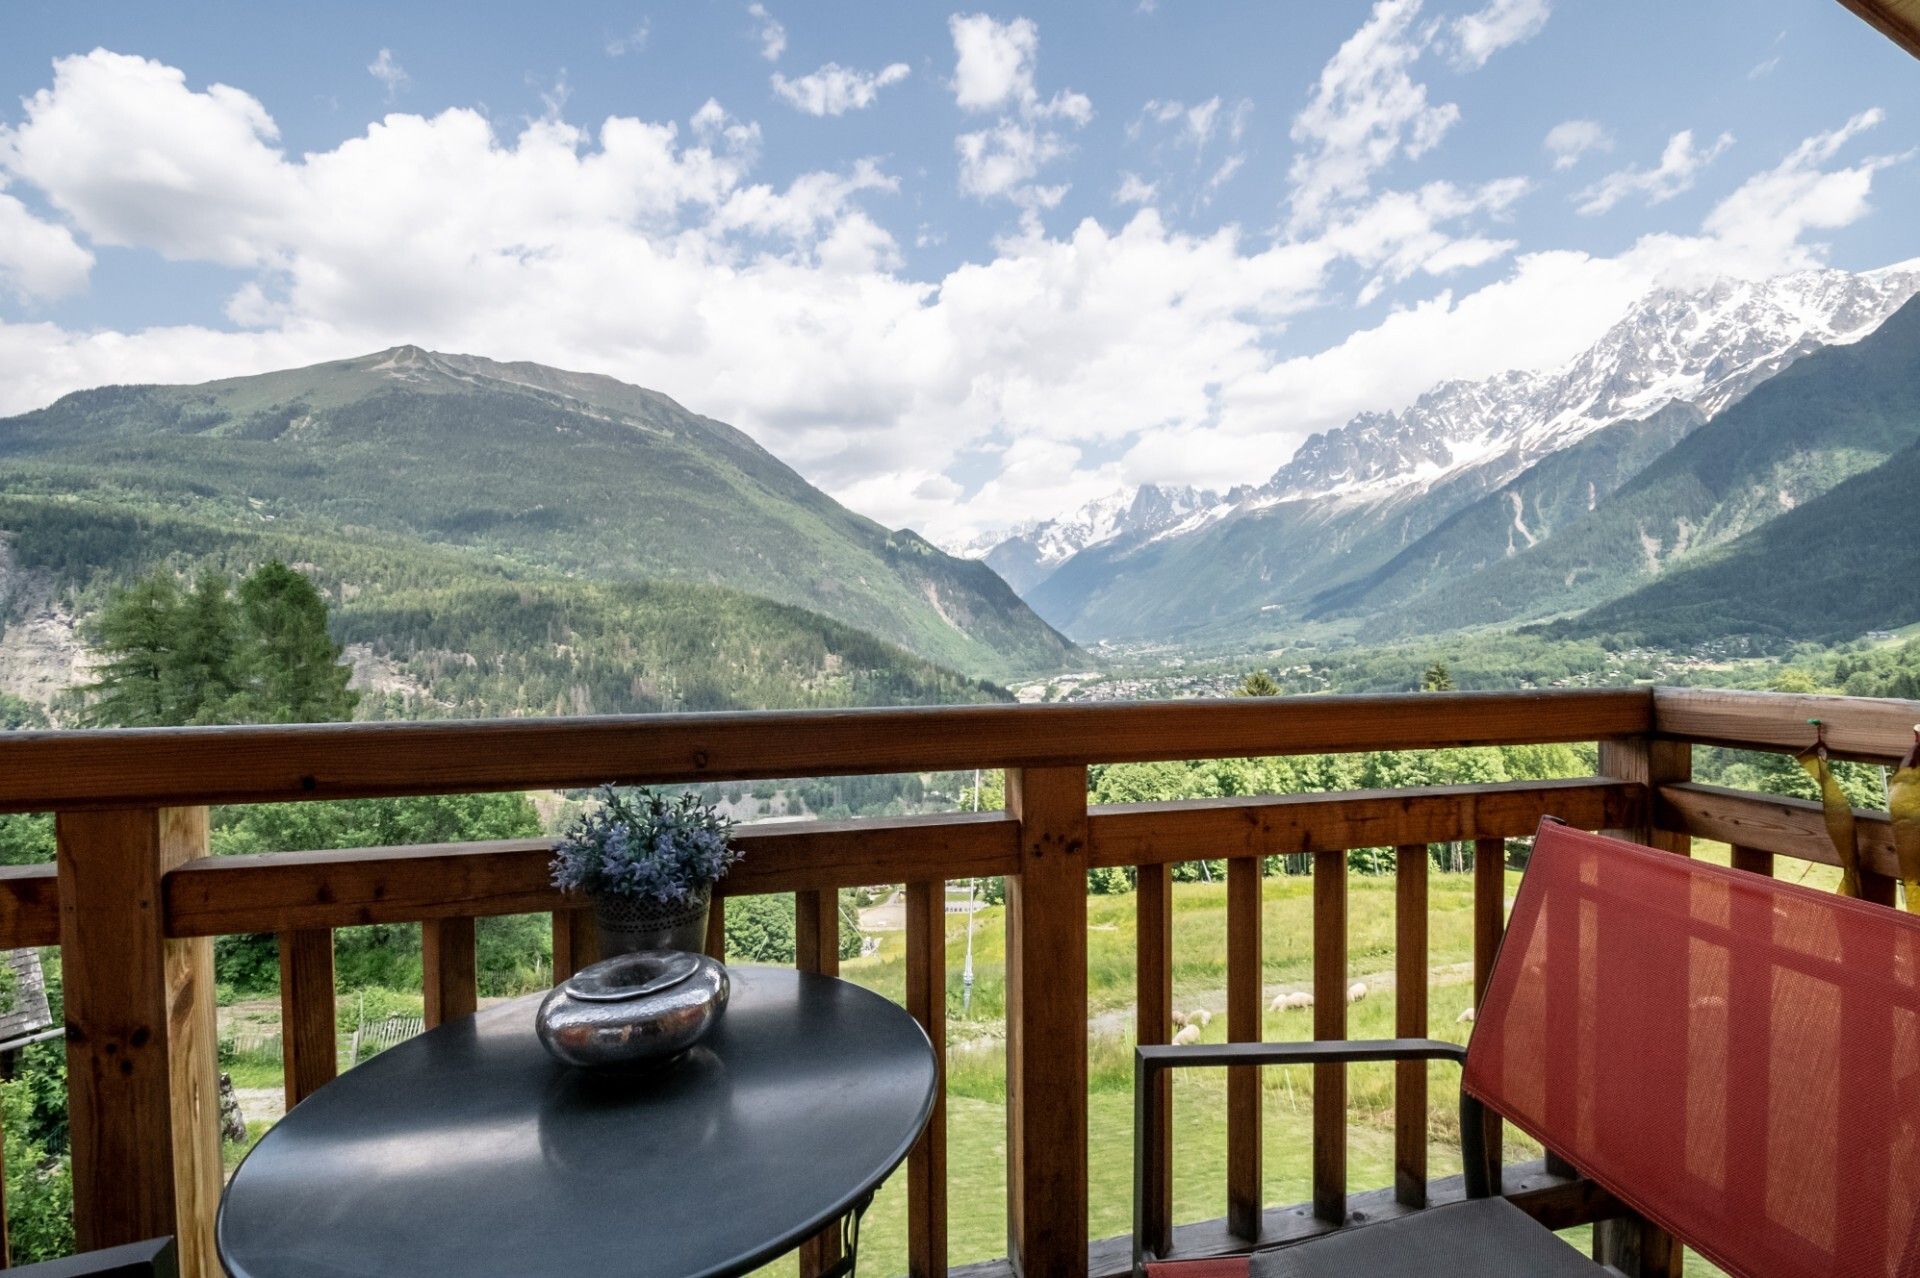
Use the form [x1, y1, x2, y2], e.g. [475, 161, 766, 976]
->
[1308, 403, 1701, 620]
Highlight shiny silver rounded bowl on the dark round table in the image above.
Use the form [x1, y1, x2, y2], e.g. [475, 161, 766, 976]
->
[534, 950, 728, 1069]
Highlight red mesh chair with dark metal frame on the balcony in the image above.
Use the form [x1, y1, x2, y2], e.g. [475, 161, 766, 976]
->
[1135, 823, 1920, 1278]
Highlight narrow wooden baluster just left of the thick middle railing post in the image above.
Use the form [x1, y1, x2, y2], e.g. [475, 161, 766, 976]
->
[906, 879, 947, 1278]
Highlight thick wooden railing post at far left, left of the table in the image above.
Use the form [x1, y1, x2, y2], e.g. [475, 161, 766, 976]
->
[56, 808, 221, 1278]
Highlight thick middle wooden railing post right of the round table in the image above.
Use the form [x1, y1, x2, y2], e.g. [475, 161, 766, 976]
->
[1006, 766, 1089, 1278]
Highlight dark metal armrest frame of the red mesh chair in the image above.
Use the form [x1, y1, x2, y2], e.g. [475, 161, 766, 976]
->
[1133, 1038, 1494, 1278]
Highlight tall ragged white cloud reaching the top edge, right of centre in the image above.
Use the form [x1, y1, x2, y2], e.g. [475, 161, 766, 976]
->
[1288, 0, 1459, 232]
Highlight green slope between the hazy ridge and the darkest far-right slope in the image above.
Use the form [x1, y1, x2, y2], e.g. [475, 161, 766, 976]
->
[1375, 301, 1920, 633]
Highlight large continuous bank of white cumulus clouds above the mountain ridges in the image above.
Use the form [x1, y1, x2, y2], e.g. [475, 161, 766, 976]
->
[0, 52, 1893, 537]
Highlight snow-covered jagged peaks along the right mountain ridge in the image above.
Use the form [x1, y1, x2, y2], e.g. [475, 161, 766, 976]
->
[1254, 259, 1920, 503]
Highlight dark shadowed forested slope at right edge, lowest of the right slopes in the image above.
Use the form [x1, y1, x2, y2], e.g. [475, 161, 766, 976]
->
[1549, 433, 1920, 649]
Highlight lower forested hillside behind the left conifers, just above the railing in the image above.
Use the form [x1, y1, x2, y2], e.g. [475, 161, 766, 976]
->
[0, 495, 1006, 718]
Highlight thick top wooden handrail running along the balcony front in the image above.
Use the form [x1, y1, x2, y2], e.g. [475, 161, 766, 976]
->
[0, 689, 1651, 812]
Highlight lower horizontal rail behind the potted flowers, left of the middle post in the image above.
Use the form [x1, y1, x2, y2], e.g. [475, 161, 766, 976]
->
[165, 814, 1018, 936]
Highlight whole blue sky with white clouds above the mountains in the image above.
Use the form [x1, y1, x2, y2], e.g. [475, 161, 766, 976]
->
[0, 0, 1920, 537]
